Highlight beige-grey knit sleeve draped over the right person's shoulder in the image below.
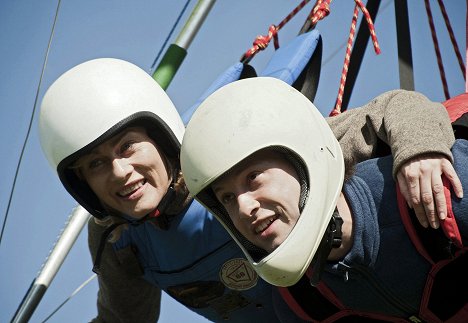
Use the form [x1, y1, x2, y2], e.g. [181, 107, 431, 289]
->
[327, 90, 455, 177]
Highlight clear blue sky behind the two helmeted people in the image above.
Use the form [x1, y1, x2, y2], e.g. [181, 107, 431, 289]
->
[0, 0, 466, 322]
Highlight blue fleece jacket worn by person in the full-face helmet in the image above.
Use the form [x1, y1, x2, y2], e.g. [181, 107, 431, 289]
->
[322, 140, 468, 318]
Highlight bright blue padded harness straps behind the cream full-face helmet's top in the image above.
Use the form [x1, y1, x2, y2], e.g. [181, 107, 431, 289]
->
[182, 30, 327, 124]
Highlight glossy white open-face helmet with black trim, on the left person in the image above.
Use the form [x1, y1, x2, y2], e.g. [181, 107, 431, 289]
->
[39, 58, 184, 218]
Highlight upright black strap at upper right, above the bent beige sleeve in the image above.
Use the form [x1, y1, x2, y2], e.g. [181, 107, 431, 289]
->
[395, 0, 414, 91]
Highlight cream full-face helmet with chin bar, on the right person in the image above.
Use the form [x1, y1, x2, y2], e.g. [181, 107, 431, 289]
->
[181, 77, 344, 286]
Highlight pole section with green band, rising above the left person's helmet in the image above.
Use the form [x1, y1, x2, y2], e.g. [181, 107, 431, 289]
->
[152, 0, 215, 90]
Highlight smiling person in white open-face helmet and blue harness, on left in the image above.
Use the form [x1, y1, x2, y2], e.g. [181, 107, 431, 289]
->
[39, 58, 308, 322]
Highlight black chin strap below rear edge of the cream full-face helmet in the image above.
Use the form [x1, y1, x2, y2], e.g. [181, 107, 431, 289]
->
[310, 208, 343, 287]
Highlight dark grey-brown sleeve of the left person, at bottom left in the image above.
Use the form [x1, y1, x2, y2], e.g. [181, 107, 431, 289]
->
[88, 218, 161, 323]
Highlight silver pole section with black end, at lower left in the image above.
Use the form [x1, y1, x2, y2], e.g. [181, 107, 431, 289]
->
[11, 206, 91, 323]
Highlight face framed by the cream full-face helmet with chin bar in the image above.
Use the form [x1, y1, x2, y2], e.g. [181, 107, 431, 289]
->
[212, 150, 301, 252]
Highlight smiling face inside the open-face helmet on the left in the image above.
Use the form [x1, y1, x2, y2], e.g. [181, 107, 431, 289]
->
[75, 127, 171, 219]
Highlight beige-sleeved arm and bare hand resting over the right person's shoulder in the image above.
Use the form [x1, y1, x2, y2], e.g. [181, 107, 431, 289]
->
[328, 90, 463, 227]
